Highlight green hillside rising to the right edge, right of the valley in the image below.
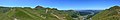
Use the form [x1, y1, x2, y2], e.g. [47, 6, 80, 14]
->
[92, 6, 120, 20]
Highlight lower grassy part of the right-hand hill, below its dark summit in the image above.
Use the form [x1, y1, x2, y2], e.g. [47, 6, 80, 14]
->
[92, 10, 120, 20]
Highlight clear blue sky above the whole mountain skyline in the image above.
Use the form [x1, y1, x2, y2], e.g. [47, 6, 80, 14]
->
[0, 0, 120, 10]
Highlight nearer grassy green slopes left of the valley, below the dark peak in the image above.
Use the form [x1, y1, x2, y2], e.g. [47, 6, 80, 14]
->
[0, 8, 72, 20]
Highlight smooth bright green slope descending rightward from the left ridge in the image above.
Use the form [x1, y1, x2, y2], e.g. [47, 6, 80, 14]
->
[15, 9, 42, 20]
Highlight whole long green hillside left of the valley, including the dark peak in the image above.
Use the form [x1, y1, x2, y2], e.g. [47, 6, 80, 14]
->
[0, 6, 79, 20]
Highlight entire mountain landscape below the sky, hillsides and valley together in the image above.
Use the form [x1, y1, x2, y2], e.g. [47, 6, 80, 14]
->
[0, 6, 120, 20]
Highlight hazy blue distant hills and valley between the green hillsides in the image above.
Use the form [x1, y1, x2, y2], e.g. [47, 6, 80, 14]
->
[76, 10, 102, 16]
